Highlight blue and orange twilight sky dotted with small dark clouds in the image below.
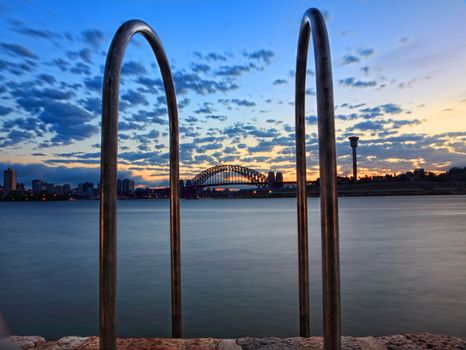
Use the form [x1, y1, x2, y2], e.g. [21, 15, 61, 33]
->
[0, 0, 466, 187]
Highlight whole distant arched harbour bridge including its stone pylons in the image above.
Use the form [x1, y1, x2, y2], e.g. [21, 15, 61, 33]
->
[185, 164, 294, 189]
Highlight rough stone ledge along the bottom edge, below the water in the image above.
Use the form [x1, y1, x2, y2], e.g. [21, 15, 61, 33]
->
[0, 333, 466, 350]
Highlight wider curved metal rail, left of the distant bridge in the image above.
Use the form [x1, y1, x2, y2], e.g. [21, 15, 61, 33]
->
[99, 20, 181, 350]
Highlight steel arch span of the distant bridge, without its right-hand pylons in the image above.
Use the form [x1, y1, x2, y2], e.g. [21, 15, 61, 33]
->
[191, 164, 267, 189]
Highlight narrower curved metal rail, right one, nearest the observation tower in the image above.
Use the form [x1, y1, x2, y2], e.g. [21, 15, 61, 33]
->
[295, 9, 341, 349]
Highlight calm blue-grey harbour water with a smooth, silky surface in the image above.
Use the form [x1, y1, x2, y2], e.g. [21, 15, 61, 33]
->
[0, 196, 466, 338]
